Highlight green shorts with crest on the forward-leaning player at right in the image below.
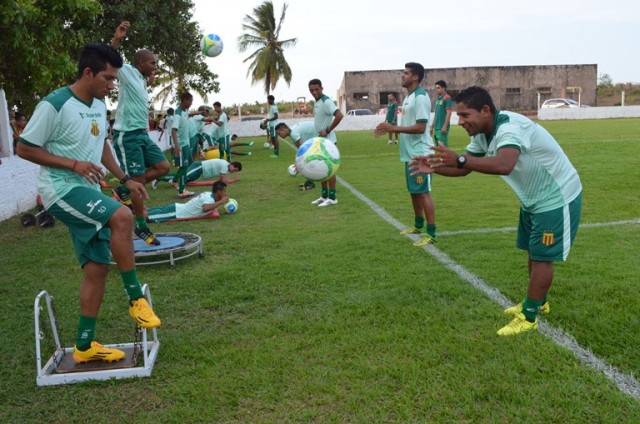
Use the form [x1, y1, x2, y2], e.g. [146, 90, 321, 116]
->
[516, 194, 582, 262]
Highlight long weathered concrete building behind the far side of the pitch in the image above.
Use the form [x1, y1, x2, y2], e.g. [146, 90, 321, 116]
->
[337, 64, 598, 113]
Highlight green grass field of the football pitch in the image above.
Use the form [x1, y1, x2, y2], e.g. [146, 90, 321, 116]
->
[0, 119, 640, 423]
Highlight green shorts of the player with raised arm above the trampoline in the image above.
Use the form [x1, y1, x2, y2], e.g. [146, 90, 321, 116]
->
[113, 130, 167, 177]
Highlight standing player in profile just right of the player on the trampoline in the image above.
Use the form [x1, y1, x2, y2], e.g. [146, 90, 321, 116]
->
[171, 91, 193, 199]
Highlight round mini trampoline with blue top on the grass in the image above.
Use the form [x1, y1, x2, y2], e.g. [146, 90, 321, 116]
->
[111, 232, 203, 266]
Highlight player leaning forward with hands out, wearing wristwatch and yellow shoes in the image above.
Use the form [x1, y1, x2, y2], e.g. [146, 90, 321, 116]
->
[411, 86, 582, 336]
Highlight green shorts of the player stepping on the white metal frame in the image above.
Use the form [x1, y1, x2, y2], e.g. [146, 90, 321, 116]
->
[47, 187, 124, 266]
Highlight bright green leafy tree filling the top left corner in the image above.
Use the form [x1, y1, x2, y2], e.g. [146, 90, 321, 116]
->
[0, 0, 101, 113]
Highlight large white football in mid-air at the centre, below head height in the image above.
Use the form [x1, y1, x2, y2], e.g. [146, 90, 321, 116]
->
[296, 137, 340, 181]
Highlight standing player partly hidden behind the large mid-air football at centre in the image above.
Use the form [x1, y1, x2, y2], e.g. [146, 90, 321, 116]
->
[309, 78, 344, 207]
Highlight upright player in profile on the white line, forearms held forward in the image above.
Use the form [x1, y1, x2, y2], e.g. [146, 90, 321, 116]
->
[375, 62, 436, 247]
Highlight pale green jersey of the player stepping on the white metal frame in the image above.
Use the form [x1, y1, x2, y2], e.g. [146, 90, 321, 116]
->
[20, 87, 107, 208]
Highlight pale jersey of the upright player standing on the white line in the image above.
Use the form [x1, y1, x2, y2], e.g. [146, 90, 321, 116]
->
[400, 87, 433, 162]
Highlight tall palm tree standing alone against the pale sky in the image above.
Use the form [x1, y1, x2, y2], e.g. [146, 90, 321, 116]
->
[238, 0, 298, 94]
